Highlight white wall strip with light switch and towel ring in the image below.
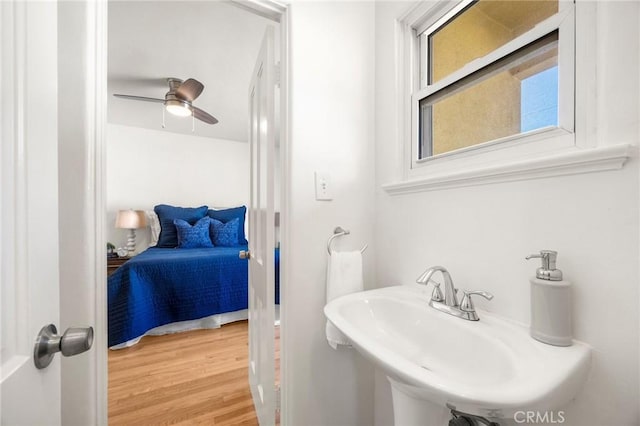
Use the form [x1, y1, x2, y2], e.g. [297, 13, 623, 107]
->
[282, 2, 375, 426]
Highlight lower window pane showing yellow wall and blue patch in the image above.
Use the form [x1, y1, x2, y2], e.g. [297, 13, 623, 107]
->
[420, 32, 558, 158]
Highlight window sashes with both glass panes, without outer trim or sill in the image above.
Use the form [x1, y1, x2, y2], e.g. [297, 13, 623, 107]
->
[412, 0, 575, 163]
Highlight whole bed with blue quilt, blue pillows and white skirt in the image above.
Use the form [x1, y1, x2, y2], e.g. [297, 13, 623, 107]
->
[108, 204, 280, 349]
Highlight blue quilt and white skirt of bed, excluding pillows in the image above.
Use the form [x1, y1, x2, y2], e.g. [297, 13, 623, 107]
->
[108, 246, 280, 349]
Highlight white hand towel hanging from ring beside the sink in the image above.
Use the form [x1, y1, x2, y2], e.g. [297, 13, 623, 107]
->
[325, 251, 364, 349]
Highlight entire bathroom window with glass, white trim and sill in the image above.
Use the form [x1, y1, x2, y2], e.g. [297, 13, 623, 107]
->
[382, 0, 632, 195]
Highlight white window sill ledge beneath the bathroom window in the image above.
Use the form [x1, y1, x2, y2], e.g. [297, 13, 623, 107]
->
[382, 144, 633, 195]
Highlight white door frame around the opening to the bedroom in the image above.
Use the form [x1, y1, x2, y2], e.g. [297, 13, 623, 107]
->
[87, 0, 291, 425]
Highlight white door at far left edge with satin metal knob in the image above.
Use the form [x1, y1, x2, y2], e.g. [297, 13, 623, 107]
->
[0, 0, 94, 426]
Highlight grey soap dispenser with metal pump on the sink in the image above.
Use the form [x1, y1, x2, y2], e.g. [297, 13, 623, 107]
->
[526, 250, 573, 346]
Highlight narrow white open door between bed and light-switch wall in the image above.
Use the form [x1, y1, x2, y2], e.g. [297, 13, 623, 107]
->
[249, 27, 276, 426]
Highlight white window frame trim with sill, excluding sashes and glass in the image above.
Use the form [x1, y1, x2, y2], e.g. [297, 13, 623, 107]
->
[381, 0, 633, 195]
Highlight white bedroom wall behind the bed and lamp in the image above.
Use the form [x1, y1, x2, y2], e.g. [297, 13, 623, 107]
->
[106, 124, 249, 250]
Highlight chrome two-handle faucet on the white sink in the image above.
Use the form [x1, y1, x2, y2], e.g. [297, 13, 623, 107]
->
[416, 266, 493, 321]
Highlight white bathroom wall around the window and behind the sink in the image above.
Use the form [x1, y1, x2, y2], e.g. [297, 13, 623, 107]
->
[375, 2, 640, 426]
